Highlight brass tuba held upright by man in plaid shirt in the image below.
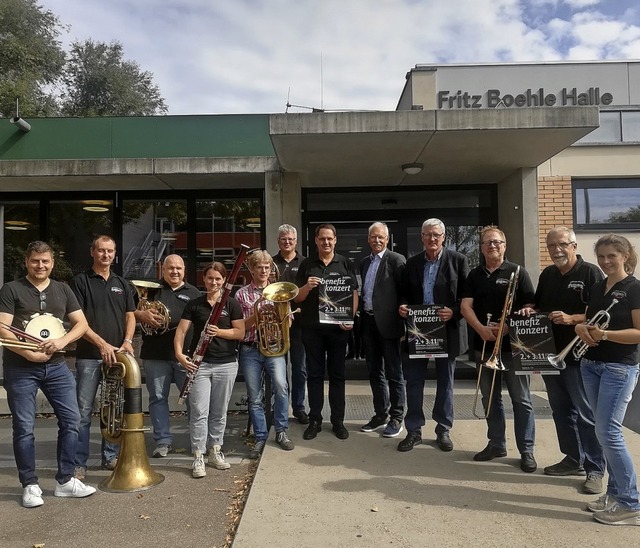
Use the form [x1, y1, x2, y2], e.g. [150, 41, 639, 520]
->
[253, 282, 300, 358]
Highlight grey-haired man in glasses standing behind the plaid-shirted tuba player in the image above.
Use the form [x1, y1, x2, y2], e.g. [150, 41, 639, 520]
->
[273, 224, 309, 424]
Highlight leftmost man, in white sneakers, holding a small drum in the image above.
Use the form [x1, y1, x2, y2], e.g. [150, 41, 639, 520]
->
[0, 241, 96, 508]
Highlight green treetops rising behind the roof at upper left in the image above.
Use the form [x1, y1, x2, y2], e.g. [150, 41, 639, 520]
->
[0, 0, 168, 117]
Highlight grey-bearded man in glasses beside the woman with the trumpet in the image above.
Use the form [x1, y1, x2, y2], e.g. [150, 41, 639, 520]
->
[524, 226, 605, 494]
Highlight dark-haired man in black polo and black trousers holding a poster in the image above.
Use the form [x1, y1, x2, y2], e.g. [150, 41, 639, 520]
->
[295, 224, 358, 440]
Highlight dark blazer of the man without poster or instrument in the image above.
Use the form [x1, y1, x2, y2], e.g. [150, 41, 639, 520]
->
[359, 249, 406, 339]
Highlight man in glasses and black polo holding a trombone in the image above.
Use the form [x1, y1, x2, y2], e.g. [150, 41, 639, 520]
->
[461, 225, 538, 473]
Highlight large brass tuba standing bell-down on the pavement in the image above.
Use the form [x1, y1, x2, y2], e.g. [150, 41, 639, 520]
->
[100, 352, 164, 493]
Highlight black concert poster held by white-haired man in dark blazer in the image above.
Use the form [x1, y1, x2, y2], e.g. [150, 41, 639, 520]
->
[407, 304, 448, 358]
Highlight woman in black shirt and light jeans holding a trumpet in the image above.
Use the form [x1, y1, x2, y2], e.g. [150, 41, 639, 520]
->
[576, 234, 640, 525]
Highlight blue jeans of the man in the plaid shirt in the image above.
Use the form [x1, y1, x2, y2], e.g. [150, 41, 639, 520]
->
[240, 344, 289, 441]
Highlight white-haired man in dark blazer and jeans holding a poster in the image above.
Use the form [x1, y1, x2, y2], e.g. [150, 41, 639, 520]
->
[398, 219, 469, 452]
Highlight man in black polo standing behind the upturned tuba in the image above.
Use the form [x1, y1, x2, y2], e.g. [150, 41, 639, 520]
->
[71, 236, 136, 481]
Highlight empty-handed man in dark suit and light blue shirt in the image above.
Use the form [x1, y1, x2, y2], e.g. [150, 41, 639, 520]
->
[360, 223, 406, 438]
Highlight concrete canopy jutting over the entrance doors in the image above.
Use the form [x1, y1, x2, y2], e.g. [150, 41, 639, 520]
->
[269, 107, 599, 187]
